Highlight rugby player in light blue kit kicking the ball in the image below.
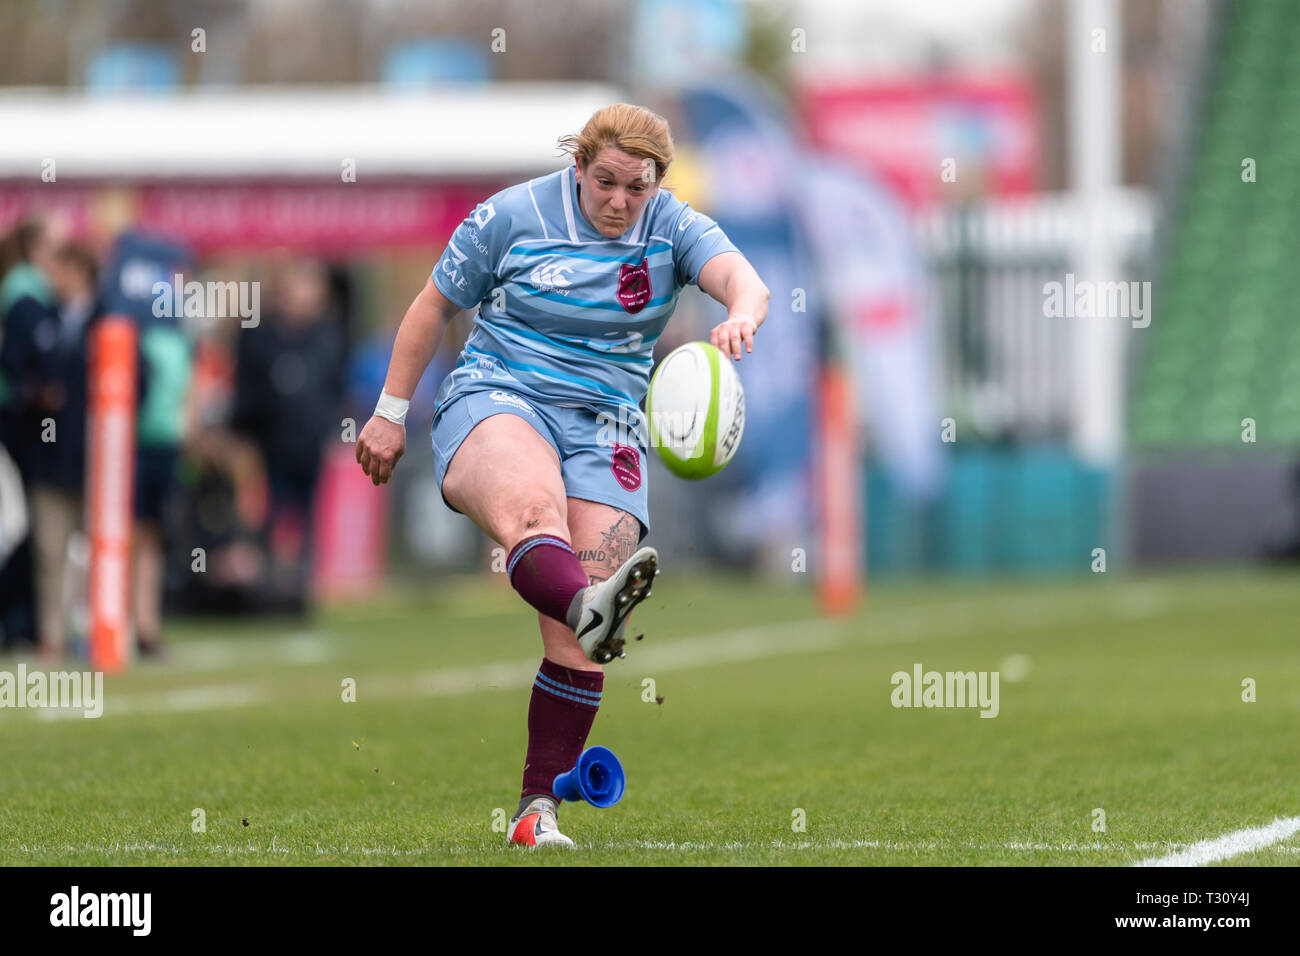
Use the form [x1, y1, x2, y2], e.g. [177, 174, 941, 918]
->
[356, 103, 770, 847]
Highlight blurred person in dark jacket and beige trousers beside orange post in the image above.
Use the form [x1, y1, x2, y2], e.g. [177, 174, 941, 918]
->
[30, 243, 103, 657]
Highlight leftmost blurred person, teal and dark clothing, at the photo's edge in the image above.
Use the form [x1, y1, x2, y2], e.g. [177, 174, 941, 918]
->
[0, 219, 59, 645]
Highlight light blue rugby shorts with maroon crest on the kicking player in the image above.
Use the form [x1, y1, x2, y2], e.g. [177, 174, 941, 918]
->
[430, 388, 650, 541]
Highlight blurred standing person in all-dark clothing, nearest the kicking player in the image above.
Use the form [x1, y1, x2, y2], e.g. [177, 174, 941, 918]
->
[231, 260, 346, 613]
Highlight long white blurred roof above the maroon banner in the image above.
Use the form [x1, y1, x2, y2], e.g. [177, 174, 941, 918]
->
[0, 83, 625, 182]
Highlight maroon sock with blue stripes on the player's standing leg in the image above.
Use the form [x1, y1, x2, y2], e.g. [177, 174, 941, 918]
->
[519, 657, 605, 810]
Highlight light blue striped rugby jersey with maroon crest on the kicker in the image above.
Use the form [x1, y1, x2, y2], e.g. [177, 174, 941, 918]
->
[433, 165, 736, 421]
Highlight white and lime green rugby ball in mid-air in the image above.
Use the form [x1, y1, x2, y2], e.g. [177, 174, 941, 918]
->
[646, 342, 745, 480]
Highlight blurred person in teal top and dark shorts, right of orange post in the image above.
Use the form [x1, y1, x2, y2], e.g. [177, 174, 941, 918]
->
[131, 286, 194, 657]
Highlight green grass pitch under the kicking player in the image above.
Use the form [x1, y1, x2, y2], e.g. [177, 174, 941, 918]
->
[0, 567, 1300, 865]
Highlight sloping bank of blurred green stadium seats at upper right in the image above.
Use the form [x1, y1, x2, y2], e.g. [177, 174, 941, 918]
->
[1130, 0, 1300, 449]
